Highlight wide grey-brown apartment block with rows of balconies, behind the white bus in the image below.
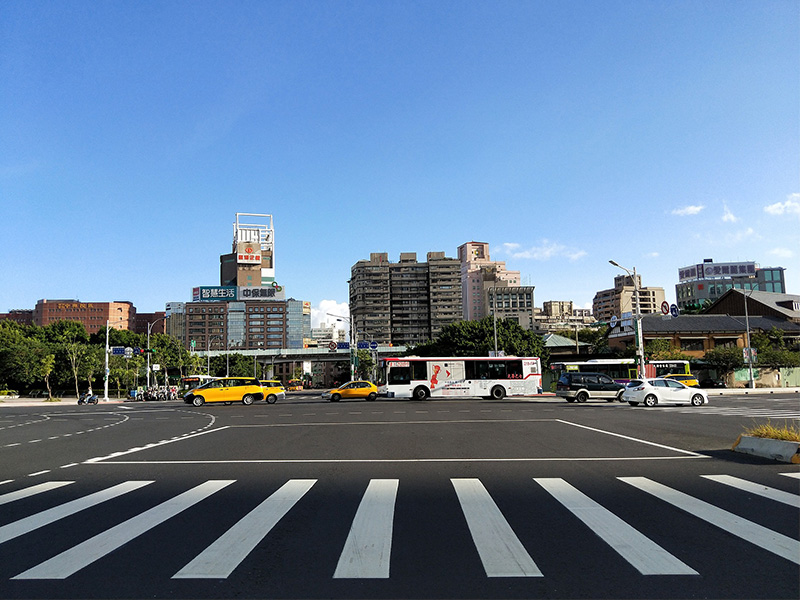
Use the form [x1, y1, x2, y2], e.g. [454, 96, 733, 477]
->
[349, 252, 461, 346]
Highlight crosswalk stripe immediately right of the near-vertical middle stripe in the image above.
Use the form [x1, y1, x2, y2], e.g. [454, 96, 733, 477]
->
[450, 479, 542, 577]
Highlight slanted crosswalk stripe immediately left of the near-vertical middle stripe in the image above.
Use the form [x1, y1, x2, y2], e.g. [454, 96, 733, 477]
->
[172, 479, 317, 579]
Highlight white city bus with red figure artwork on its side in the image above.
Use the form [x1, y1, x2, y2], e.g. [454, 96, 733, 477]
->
[378, 356, 542, 400]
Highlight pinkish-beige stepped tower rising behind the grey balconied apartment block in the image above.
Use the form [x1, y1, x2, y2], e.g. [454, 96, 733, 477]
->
[458, 242, 520, 321]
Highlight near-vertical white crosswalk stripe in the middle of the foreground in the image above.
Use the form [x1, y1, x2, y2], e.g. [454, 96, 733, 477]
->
[333, 479, 400, 579]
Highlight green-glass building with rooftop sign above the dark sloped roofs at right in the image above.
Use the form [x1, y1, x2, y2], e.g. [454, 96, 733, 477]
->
[675, 258, 786, 309]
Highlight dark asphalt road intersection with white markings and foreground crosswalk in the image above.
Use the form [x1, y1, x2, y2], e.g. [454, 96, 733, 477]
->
[0, 393, 800, 599]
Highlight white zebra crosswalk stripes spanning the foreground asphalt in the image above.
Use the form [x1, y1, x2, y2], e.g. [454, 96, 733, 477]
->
[0, 472, 800, 581]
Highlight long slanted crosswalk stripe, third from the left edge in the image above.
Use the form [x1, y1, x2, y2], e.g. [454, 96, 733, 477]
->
[12, 480, 235, 579]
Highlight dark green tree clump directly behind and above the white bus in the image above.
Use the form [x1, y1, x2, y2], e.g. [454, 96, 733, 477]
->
[409, 317, 548, 363]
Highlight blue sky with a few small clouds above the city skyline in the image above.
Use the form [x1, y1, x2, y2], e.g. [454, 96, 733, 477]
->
[0, 0, 800, 328]
